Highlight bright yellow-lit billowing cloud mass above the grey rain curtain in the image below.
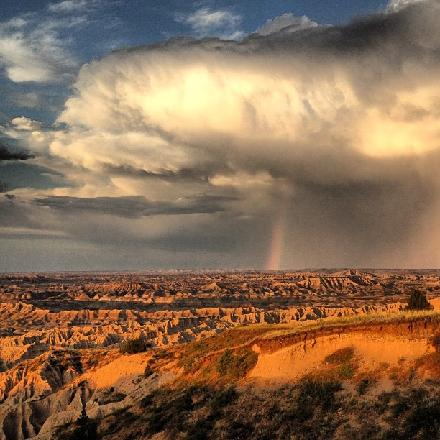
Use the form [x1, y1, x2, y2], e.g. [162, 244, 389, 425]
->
[52, 2, 440, 179]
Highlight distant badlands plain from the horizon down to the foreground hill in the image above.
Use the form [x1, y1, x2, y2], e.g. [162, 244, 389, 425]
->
[0, 270, 440, 363]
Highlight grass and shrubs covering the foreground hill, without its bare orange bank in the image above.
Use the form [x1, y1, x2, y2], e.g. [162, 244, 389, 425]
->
[59, 310, 440, 440]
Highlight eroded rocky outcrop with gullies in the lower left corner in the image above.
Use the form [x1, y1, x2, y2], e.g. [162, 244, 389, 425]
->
[0, 350, 174, 440]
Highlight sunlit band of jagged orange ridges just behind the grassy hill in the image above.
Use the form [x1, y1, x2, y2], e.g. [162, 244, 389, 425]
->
[0, 303, 403, 365]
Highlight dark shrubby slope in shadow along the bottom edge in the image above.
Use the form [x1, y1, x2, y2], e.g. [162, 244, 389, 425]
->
[78, 377, 440, 440]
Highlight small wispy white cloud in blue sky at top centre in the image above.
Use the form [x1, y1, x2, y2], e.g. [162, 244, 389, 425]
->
[177, 8, 244, 39]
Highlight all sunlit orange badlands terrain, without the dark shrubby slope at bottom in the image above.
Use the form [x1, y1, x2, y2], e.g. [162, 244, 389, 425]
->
[0, 270, 440, 440]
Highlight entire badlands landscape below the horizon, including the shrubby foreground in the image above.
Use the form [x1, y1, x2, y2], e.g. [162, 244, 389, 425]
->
[0, 270, 440, 440]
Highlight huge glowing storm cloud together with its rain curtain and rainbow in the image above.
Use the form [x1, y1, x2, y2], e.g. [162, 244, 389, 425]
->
[3, 0, 440, 268]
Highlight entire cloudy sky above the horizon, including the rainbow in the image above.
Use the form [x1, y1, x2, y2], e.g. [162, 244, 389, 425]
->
[0, 0, 440, 272]
